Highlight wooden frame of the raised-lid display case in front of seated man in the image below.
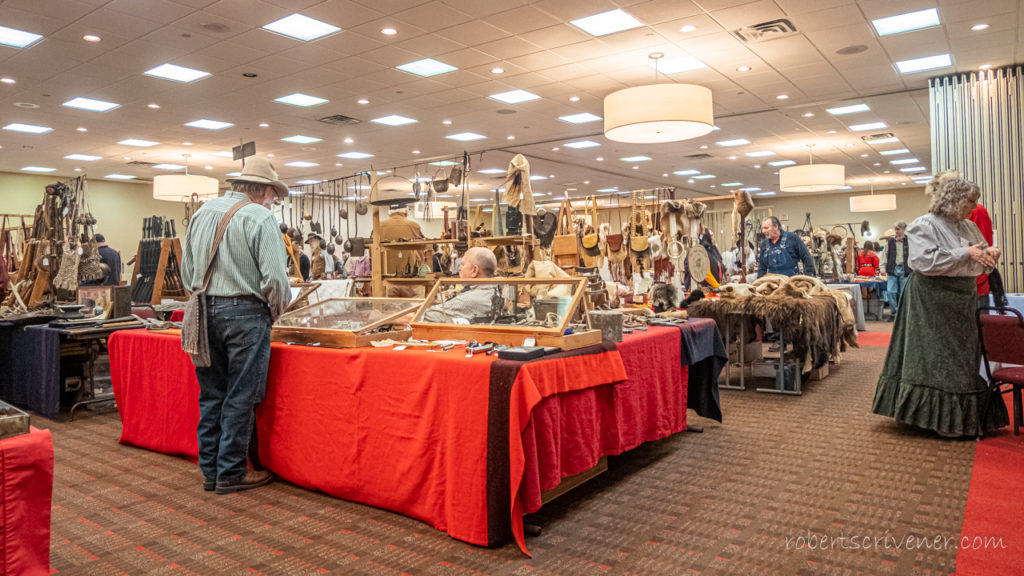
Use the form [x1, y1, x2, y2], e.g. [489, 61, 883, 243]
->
[410, 277, 601, 349]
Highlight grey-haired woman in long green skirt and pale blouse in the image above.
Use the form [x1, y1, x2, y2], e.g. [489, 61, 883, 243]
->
[872, 170, 1010, 437]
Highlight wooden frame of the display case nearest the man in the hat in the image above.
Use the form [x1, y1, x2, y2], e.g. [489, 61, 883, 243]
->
[270, 297, 423, 348]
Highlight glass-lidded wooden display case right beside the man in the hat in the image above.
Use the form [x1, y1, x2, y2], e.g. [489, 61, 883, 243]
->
[270, 298, 423, 348]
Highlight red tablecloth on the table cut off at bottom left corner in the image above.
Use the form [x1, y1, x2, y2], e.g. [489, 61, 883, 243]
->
[0, 427, 53, 576]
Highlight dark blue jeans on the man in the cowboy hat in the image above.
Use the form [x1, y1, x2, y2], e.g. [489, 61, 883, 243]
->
[196, 296, 271, 482]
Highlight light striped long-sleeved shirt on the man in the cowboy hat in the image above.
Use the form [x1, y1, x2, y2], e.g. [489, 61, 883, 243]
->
[181, 191, 291, 320]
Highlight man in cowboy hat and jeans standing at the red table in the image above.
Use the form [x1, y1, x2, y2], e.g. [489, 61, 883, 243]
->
[181, 157, 291, 494]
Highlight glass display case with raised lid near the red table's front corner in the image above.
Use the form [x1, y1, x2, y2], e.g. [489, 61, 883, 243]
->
[411, 278, 601, 349]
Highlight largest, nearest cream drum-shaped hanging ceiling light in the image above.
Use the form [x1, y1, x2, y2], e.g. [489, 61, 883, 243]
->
[604, 52, 715, 143]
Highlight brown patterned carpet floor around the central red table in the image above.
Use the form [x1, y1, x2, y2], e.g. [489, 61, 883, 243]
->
[34, 323, 975, 576]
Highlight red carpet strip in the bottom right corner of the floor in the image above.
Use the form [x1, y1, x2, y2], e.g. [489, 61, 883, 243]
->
[956, 395, 1024, 576]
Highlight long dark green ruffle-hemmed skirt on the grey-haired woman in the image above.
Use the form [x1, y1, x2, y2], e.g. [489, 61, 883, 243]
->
[872, 273, 1010, 436]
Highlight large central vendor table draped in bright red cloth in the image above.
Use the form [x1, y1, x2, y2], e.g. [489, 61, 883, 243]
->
[111, 321, 724, 551]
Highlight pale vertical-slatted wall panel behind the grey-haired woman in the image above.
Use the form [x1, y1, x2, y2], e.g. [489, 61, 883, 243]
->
[929, 66, 1024, 292]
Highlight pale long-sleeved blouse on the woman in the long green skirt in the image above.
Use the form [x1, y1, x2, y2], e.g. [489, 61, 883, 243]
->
[906, 212, 992, 276]
